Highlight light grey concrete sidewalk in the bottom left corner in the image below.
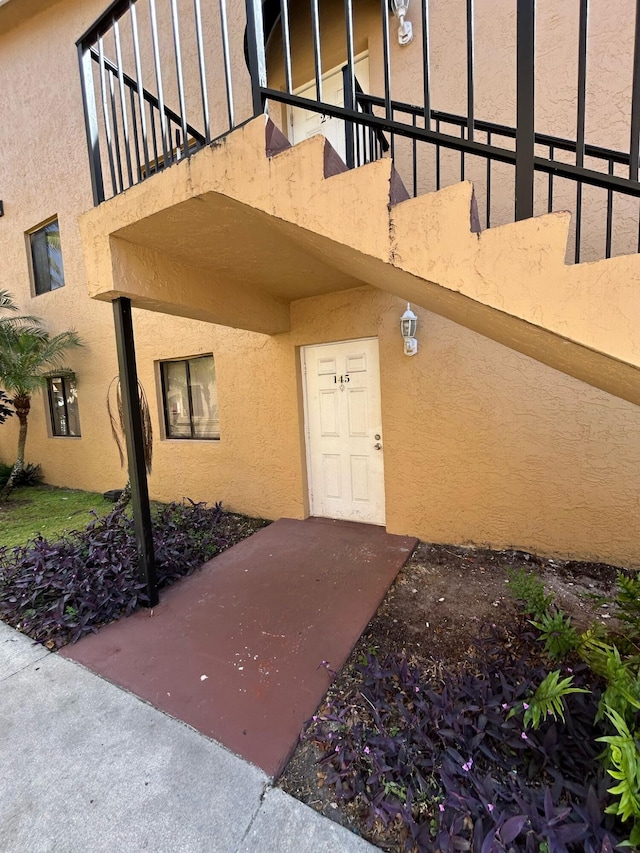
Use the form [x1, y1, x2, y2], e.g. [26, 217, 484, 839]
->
[0, 623, 377, 853]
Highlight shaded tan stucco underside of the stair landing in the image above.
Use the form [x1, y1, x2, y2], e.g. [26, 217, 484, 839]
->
[107, 192, 370, 334]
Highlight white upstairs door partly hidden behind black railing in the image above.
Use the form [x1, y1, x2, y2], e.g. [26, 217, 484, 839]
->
[289, 54, 369, 166]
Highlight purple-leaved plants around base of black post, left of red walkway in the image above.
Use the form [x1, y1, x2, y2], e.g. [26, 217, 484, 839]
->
[0, 502, 233, 648]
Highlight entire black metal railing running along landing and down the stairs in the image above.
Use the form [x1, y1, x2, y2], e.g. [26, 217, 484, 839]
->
[78, 0, 640, 261]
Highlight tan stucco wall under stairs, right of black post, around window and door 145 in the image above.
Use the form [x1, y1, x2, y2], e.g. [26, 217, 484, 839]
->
[107, 288, 640, 563]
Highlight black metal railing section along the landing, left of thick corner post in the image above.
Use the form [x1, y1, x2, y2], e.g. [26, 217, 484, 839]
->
[77, 0, 242, 204]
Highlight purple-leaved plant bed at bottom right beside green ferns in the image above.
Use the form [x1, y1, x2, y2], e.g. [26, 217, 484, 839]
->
[306, 629, 616, 853]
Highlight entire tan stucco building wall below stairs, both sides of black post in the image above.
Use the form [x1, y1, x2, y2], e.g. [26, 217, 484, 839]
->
[0, 0, 640, 564]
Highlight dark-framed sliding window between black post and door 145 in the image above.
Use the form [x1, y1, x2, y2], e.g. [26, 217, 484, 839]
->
[160, 355, 220, 439]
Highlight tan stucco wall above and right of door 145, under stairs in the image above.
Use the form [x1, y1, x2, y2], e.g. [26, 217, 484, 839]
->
[292, 291, 640, 561]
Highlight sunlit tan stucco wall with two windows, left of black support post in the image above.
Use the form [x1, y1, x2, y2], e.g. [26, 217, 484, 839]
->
[0, 0, 118, 488]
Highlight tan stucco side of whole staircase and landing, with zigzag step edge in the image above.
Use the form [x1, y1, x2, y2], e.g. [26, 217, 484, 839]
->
[80, 117, 640, 403]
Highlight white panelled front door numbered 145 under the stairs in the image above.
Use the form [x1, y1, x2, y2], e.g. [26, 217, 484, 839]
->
[302, 339, 385, 524]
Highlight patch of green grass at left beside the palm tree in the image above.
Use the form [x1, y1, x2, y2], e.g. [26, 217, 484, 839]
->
[0, 486, 113, 546]
